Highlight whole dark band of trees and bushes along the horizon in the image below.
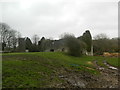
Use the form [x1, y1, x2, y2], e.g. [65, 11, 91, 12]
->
[0, 23, 120, 56]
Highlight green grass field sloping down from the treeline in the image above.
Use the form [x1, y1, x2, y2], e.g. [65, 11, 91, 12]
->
[2, 52, 118, 88]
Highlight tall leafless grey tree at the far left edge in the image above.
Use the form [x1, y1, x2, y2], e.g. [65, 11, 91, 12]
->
[0, 23, 20, 51]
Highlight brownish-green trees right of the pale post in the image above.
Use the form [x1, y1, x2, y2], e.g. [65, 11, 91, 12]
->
[93, 34, 120, 55]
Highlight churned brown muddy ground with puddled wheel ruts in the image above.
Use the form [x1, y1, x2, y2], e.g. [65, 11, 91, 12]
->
[51, 60, 120, 88]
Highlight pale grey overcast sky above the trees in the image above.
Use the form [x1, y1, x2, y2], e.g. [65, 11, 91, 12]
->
[0, 0, 118, 39]
